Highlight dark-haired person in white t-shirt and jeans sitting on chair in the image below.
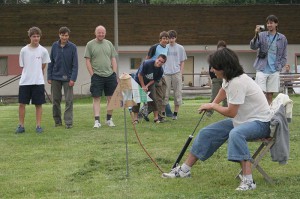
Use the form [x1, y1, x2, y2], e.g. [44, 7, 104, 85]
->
[162, 48, 271, 191]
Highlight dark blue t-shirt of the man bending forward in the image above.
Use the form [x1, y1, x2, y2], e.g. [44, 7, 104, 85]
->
[134, 59, 164, 85]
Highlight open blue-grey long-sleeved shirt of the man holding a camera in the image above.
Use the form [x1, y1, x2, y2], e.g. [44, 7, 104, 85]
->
[250, 31, 287, 71]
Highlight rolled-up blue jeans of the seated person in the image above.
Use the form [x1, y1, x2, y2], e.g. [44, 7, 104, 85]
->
[191, 119, 270, 162]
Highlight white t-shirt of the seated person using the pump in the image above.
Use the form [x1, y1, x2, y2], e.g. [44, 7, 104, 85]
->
[222, 74, 271, 126]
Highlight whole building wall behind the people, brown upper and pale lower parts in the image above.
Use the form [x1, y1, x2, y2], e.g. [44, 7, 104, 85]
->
[0, 4, 300, 95]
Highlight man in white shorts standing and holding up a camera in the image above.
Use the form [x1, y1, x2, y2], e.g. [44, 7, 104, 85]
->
[250, 15, 288, 104]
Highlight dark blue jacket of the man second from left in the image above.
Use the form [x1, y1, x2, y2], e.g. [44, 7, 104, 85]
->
[47, 40, 78, 82]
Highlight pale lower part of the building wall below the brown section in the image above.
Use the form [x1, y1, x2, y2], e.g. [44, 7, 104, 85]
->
[0, 45, 300, 95]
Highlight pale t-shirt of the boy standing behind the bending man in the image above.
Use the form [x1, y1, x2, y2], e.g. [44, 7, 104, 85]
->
[163, 43, 187, 75]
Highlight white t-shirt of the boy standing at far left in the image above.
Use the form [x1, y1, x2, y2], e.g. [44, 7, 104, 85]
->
[19, 45, 51, 86]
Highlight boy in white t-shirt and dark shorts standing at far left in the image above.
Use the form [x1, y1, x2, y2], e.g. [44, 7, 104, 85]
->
[16, 27, 50, 133]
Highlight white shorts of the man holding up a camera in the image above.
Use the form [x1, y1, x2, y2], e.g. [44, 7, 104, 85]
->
[255, 71, 280, 93]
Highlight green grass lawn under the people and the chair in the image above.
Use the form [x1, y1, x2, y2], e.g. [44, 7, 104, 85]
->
[0, 96, 300, 199]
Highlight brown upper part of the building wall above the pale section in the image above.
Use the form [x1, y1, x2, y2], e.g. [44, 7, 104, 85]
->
[0, 4, 300, 46]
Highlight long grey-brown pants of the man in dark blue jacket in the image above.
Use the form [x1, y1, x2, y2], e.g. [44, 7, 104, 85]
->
[51, 80, 73, 125]
